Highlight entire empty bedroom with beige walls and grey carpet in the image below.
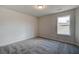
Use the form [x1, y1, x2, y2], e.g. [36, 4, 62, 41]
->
[0, 5, 79, 54]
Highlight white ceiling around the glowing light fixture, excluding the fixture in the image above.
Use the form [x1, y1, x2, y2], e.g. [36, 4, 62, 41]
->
[1, 5, 78, 16]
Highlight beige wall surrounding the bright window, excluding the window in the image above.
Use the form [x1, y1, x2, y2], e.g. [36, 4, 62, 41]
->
[39, 10, 75, 43]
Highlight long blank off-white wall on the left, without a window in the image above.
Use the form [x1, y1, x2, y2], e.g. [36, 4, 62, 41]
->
[0, 8, 37, 46]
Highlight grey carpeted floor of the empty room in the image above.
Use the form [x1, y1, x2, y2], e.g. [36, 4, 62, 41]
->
[0, 38, 79, 54]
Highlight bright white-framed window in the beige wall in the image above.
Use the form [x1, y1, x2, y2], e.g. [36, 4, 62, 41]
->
[57, 15, 70, 35]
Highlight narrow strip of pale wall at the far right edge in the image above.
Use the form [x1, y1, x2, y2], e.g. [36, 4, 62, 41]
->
[75, 8, 79, 44]
